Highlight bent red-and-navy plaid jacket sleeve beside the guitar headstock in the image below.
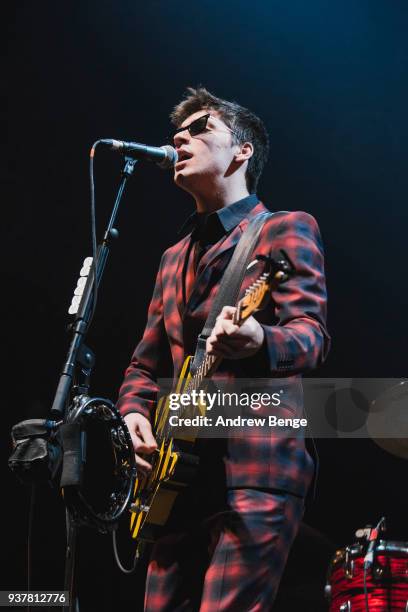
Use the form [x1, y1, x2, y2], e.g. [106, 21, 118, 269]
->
[260, 212, 330, 376]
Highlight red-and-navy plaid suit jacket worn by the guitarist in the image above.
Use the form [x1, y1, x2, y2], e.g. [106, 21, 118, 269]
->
[118, 203, 330, 496]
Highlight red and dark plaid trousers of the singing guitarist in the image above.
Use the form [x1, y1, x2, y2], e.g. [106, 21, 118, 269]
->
[145, 488, 304, 612]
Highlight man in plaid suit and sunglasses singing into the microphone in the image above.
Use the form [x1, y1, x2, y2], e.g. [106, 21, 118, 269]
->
[118, 87, 329, 612]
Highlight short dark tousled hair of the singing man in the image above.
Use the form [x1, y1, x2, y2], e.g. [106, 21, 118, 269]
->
[170, 86, 269, 193]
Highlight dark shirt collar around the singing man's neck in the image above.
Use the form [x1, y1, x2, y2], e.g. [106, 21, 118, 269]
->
[178, 193, 259, 236]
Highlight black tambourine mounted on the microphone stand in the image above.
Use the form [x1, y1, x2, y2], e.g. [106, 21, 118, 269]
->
[61, 395, 136, 533]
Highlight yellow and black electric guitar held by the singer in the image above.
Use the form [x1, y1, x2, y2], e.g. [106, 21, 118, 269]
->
[130, 251, 294, 546]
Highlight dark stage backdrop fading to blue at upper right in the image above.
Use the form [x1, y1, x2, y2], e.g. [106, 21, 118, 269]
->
[1, 0, 408, 609]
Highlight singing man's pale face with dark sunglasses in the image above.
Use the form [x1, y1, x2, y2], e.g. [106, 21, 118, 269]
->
[174, 110, 238, 194]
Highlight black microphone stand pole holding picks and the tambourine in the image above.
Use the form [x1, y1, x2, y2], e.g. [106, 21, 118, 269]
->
[51, 157, 137, 612]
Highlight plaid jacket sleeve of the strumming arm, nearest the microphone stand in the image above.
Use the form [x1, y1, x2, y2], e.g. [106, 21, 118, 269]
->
[117, 258, 168, 418]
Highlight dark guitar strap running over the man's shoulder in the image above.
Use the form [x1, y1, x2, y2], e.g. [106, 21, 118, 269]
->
[190, 212, 273, 375]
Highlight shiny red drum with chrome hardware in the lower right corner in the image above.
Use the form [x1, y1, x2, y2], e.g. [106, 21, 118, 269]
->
[325, 540, 408, 612]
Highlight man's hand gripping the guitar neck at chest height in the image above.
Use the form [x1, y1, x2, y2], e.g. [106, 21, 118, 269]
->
[206, 306, 264, 359]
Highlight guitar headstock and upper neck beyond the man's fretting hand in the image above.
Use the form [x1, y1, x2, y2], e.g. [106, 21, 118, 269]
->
[236, 249, 295, 323]
